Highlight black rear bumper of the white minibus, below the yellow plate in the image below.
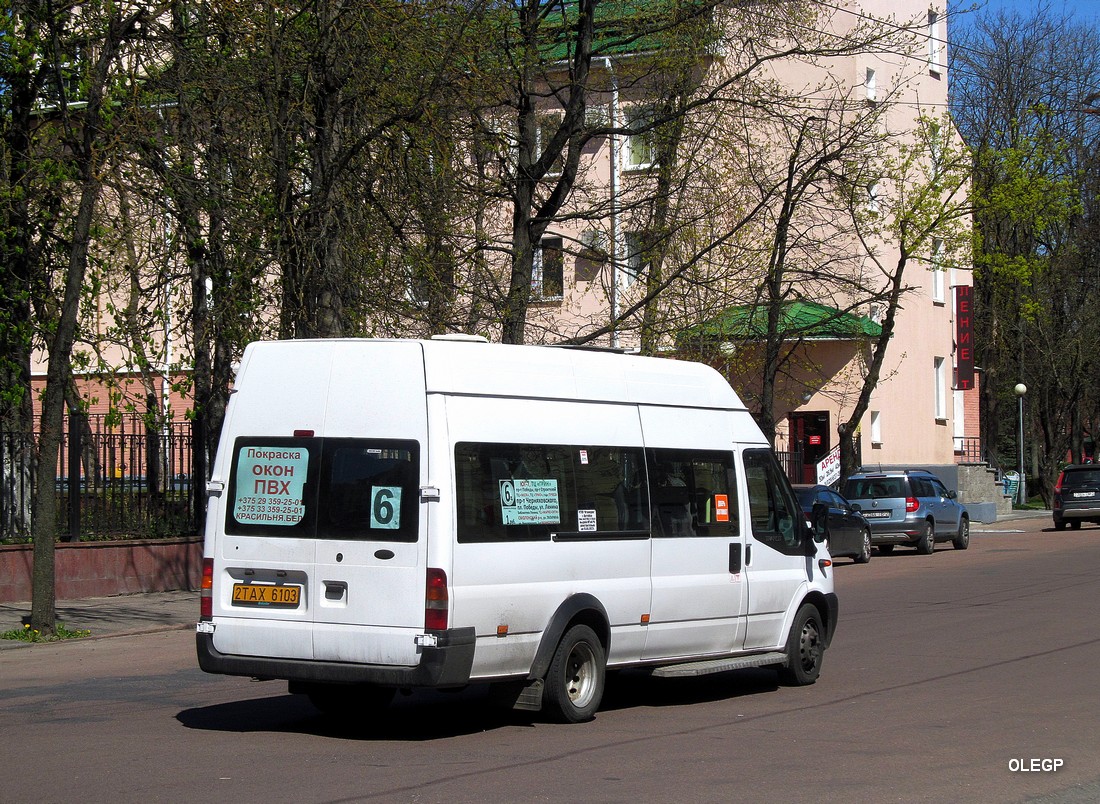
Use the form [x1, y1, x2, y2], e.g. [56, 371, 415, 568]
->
[195, 627, 474, 687]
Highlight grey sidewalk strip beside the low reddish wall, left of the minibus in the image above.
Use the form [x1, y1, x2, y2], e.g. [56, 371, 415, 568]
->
[0, 592, 199, 651]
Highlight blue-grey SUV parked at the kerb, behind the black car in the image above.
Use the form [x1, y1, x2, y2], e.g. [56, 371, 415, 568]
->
[844, 470, 970, 554]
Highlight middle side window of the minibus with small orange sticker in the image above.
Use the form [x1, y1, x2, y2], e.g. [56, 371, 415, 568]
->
[646, 449, 739, 538]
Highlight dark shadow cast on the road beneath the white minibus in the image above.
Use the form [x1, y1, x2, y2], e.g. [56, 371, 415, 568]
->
[176, 669, 779, 742]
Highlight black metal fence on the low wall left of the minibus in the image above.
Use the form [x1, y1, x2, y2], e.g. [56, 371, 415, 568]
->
[0, 416, 201, 542]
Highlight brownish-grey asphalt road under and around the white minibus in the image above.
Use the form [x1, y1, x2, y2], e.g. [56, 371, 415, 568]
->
[0, 520, 1100, 804]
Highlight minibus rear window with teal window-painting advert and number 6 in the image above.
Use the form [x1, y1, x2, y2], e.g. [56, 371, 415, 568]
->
[226, 438, 420, 541]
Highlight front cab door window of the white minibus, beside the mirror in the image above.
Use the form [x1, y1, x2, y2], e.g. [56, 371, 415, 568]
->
[744, 450, 806, 555]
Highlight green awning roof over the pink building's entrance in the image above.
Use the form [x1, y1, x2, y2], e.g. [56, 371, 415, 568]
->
[678, 299, 882, 343]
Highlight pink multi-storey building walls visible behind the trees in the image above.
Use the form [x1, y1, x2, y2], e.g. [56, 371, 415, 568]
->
[32, 0, 978, 486]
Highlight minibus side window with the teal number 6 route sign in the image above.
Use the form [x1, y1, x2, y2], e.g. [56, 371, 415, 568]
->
[454, 442, 649, 542]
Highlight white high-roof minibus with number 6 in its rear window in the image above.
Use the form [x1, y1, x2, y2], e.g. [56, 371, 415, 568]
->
[197, 337, 837, 723]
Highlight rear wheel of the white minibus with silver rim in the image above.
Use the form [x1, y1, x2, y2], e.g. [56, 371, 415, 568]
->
[542, 625, 607, 723]
